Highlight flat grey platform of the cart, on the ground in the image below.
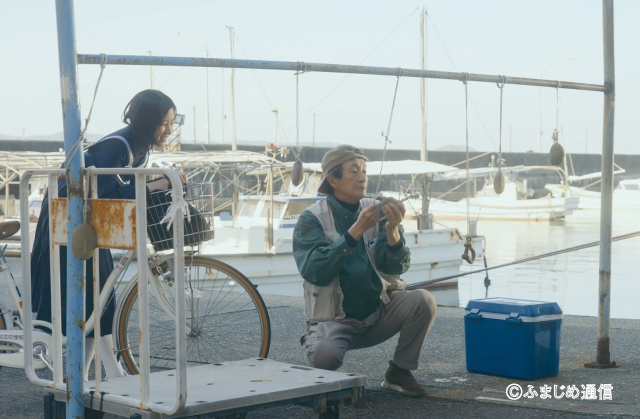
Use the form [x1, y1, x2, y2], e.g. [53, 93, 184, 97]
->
[46, 358, 367, 419]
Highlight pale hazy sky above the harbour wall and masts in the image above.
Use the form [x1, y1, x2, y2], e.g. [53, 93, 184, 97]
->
[0, 0, 640, 154]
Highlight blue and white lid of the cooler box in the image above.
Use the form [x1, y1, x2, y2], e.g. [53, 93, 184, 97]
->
[465, 297, 562, 321]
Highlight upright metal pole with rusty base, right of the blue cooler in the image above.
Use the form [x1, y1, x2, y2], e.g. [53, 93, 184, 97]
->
[585, 0, 616, 368]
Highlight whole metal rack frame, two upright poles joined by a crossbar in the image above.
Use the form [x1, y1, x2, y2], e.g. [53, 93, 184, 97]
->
[52, 0, 615, 418]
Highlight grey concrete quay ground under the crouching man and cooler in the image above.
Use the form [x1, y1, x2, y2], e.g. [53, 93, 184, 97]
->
[0, 290, 640, 419]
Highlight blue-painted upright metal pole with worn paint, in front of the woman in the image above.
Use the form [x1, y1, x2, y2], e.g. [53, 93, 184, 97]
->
[54, 0, 85, 419]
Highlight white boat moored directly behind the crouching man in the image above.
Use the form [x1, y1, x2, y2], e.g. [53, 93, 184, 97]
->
[202, 195, 484, 296]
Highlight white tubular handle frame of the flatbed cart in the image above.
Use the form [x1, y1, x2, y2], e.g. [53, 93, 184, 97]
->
[20, 168, 187, 417]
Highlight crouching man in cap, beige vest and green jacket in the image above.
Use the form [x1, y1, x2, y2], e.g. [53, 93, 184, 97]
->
[293, 145, 436, 397]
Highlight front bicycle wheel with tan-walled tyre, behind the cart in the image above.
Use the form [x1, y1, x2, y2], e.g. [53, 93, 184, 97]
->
[114, 256, 271, 374]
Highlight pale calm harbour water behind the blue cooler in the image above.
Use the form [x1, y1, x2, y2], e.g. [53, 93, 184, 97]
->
[435, 210, 640, 319]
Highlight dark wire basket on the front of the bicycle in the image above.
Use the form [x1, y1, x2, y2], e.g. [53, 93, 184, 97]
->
[147, 183, 214, 252]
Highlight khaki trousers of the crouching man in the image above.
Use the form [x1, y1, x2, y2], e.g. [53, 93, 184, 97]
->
[300, 289, 436, 370]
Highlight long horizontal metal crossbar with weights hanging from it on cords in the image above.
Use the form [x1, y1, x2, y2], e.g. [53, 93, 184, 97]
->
[78, 54, 608, 92]
